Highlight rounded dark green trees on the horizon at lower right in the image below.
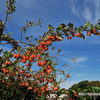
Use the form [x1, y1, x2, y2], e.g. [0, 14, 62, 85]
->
[68, 80, 100, 100]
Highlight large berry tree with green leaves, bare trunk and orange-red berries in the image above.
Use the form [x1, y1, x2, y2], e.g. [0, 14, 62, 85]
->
[0, 0, 100, 100]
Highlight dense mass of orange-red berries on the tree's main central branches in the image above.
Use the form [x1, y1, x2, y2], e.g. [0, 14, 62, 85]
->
[2, 35, 63, 96]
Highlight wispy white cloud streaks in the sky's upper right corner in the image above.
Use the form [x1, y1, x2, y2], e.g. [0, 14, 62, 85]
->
[70, 0, 100, 23]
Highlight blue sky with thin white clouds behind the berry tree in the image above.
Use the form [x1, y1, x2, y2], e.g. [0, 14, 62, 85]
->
[0, 0, 100, 89]
